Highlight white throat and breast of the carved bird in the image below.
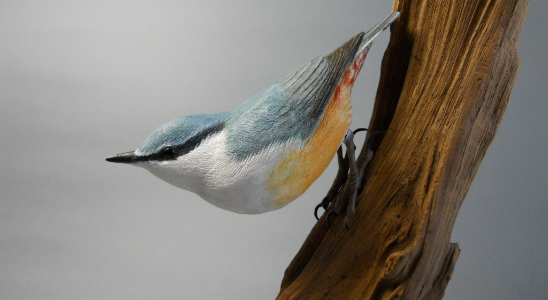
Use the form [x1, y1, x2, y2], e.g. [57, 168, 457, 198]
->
[138, 131, 302, 214]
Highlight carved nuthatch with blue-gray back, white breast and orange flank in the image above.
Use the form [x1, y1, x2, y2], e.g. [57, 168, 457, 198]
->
[106, 12, 399, 225]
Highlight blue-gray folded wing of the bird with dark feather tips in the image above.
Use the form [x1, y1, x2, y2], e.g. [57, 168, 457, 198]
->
[225, 33, 364, 159]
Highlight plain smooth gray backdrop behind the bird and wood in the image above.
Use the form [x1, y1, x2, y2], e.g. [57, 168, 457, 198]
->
[0, 0, 548, 299]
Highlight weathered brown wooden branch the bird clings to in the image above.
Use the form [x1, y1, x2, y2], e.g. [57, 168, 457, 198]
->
[278, 0, 528, 299]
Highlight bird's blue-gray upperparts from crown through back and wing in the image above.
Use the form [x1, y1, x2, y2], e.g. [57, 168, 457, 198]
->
[138, 33, 363, 160]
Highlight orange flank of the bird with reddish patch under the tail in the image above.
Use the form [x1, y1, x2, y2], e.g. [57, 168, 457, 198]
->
[265, 51, 367, 206]
